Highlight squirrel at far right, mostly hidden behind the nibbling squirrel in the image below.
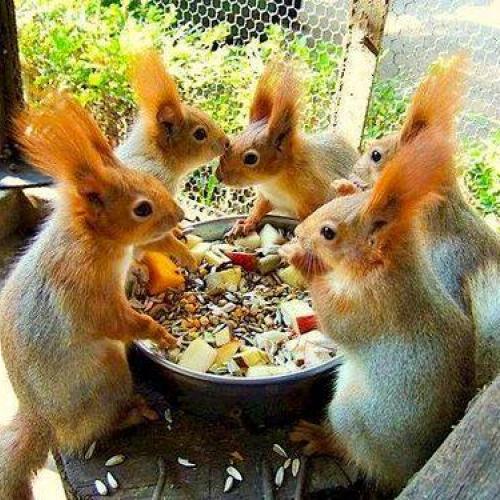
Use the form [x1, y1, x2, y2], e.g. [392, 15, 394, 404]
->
[354, 54, 500, 386]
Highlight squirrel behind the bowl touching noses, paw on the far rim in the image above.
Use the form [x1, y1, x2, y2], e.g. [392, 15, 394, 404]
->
[217, 62, 358, 235]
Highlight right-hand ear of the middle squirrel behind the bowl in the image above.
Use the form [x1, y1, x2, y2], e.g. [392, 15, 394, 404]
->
[268, 66, 300, 150]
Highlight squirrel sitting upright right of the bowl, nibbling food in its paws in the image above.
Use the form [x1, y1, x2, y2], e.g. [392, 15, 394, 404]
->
[284, 126, 475, 494]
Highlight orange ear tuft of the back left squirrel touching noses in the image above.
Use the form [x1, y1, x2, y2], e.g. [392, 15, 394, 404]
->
[132, 50, 184, 133]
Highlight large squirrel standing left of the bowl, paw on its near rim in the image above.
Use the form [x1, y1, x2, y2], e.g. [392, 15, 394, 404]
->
[0, 96, 183, 500]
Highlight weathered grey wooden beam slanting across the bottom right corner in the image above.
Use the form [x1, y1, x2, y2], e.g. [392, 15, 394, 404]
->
[398, 375, 500, 500]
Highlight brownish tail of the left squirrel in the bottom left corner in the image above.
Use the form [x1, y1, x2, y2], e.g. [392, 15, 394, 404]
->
[0, 413, 52, 500]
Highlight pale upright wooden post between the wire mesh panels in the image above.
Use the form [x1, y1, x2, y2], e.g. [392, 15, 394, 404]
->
[333, 0, 389, 147]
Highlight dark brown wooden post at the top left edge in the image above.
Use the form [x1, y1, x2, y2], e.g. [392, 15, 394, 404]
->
[0, 0, 23, 152]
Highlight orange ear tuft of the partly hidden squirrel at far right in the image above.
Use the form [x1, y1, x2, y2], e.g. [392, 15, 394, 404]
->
[400, 52, 468, 144]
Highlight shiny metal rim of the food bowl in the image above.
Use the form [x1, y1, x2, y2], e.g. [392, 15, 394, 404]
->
[134, 215, 341, 386]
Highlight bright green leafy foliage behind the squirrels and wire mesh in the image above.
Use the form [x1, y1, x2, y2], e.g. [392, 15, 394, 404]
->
[17, 0, 500, 215]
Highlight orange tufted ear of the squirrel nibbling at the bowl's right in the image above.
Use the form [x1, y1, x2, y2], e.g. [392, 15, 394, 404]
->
[362, 127, 455, 248]
